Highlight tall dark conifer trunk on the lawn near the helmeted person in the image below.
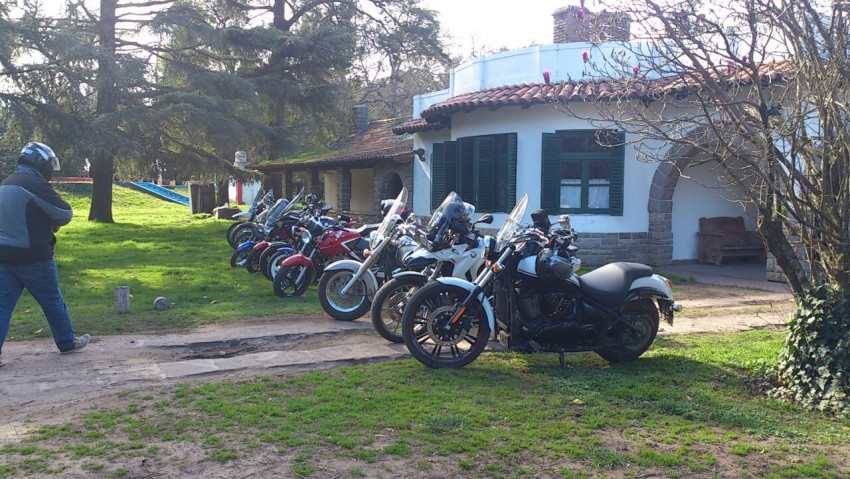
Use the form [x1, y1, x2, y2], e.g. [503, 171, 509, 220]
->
[89, 0, 118, 223]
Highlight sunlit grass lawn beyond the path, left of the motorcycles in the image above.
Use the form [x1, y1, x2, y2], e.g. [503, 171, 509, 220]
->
[8, 186, 322, 340]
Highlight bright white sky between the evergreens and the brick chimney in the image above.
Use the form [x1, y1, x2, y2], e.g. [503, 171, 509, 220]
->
[422, 0, 576, 58]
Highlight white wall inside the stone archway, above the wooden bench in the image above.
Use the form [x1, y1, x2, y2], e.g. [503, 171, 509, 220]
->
[673, 159, 757, 261]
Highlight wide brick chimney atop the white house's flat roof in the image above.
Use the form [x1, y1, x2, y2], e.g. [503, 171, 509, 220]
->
[552, 7, 632, 43]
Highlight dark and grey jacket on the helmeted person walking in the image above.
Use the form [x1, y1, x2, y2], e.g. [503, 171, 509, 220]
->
[0, 165, 73, 264]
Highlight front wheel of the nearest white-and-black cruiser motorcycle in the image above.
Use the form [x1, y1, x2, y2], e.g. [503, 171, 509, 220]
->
[401, 282, 490, 368]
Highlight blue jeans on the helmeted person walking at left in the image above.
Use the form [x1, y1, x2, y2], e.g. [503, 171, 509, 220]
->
[0, 258, 74, 351]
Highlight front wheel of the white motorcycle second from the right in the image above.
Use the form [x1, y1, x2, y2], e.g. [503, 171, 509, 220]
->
[372, 276, 428, 343]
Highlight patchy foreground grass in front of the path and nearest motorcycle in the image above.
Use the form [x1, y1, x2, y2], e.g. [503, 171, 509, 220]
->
[0, 331, 850, 478]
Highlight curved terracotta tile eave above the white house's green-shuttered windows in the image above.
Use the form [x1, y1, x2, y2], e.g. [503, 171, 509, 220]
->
[393, 61, 794, 134]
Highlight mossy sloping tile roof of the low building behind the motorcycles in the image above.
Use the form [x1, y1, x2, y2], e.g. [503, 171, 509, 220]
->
[251, 118, 413, 171]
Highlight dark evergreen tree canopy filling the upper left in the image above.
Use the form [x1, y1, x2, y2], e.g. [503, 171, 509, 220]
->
[0, 0, 446, 222]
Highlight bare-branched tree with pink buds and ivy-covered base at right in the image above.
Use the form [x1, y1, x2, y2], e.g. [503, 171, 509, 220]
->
[564, 0, 850, 413]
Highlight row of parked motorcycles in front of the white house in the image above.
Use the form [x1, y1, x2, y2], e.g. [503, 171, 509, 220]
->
[227, 188, 680, 368]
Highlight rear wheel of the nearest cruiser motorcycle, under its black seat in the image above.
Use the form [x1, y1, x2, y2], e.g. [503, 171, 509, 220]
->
[596, 299, 658, 363]
